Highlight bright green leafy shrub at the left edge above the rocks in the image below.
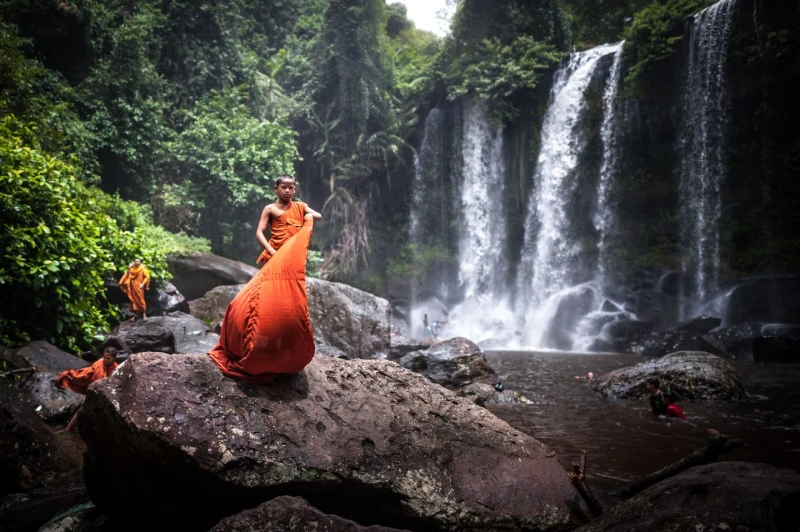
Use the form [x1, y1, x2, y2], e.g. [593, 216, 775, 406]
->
[0, 116, 207, 351]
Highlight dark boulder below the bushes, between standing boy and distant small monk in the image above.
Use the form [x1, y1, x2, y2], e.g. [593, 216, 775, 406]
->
[167, 253, 258, 301]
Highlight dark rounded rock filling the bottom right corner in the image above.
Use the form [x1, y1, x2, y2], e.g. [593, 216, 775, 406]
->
[576, 462, 800, 532]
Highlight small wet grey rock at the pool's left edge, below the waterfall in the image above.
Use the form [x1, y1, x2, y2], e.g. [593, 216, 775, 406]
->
[399, 338, 494, 389]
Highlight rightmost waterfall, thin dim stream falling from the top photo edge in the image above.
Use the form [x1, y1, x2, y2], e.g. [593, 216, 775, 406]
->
[678, 0, 735, 317]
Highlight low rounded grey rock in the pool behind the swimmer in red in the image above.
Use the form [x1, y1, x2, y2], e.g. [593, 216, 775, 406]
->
[593, 351, 746, 401]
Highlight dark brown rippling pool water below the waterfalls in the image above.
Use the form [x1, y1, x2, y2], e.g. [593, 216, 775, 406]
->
[486, 351, 800, 492]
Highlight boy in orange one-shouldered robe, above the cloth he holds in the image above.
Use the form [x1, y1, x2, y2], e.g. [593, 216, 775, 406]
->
[256, 174, 322, 264]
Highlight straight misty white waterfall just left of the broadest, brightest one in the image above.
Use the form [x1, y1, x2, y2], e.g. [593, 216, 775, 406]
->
[448, 100, 513, 341]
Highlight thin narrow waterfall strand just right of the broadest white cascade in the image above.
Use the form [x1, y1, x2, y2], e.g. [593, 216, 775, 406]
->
[594, 41, 625, 282]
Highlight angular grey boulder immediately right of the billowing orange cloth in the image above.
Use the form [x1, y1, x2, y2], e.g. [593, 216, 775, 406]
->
[306, 277, 391, 358]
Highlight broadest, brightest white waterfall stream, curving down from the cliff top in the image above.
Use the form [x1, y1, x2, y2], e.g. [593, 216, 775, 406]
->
[518, 44, 621, 348]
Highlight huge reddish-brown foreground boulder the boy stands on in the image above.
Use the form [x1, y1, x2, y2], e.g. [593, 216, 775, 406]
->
[78, 353, 586, 531]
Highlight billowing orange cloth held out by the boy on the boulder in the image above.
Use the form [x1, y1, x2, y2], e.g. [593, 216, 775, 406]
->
[208, 215, 315, 384]
